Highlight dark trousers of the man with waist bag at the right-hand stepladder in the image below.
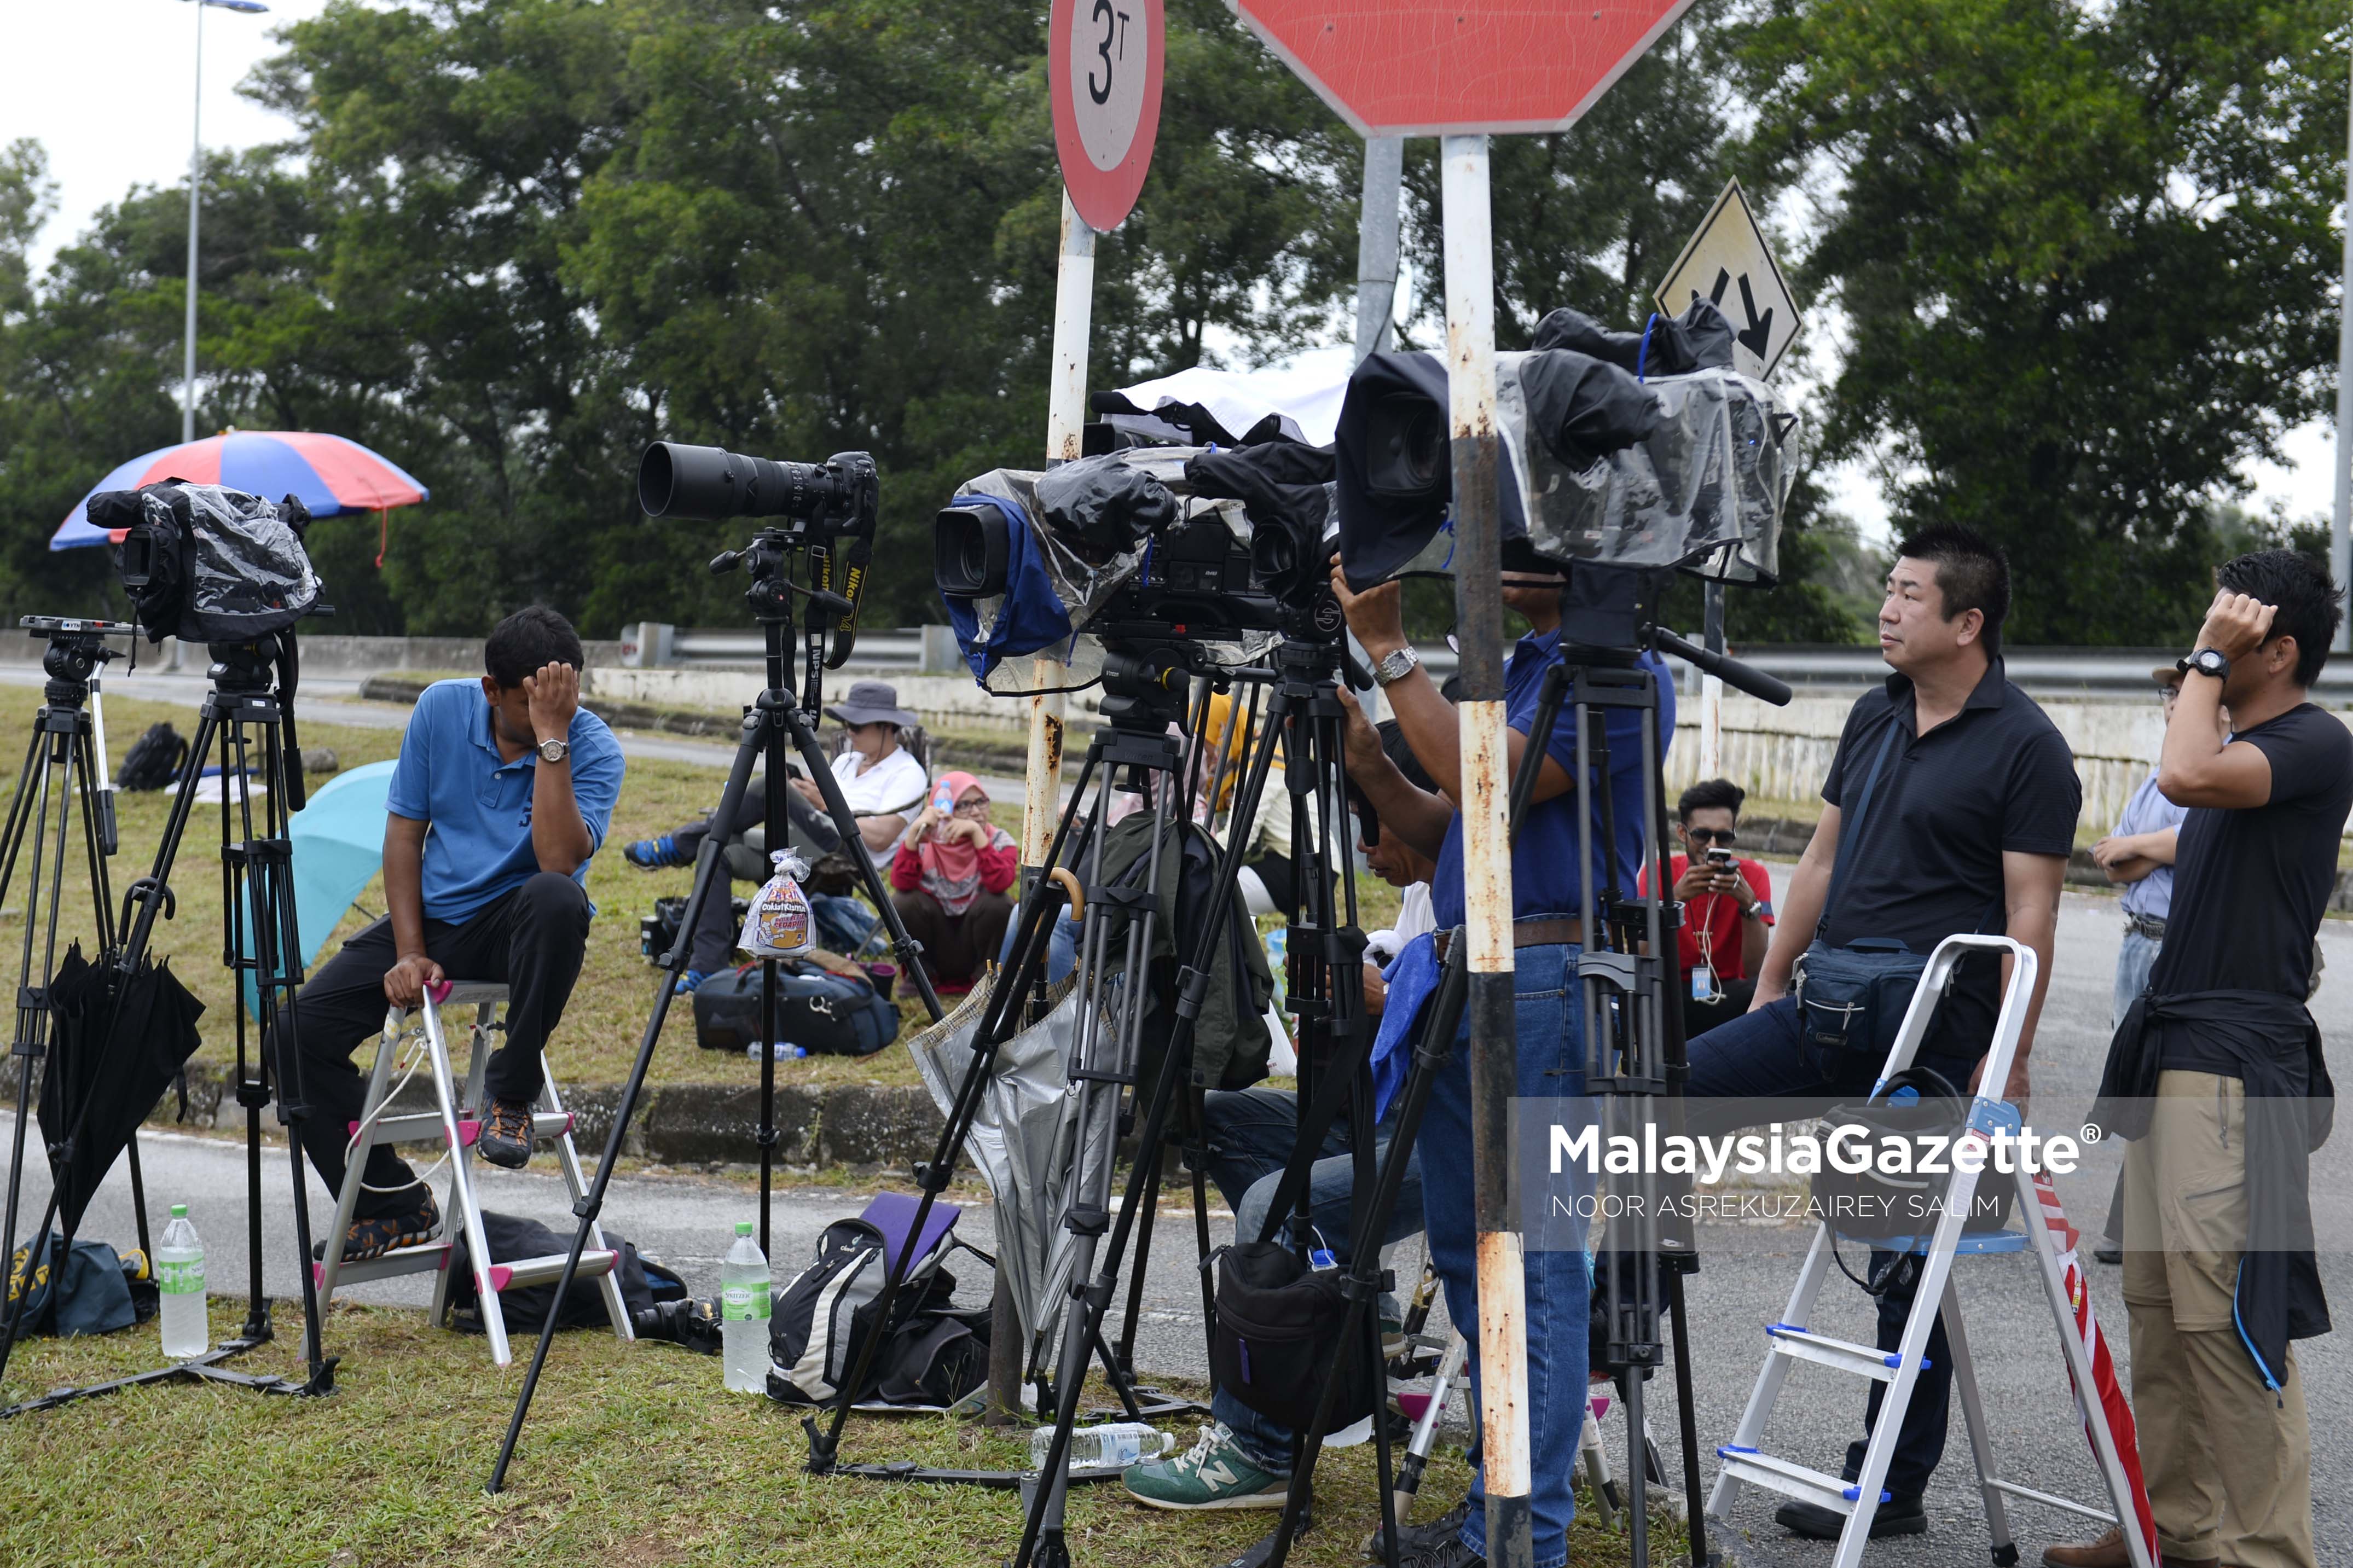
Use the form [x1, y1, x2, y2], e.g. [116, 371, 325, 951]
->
[1685, 997, 1977, 1497]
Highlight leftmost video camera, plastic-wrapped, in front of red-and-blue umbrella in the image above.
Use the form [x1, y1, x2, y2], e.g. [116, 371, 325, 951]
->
[89, 480, 322, 647]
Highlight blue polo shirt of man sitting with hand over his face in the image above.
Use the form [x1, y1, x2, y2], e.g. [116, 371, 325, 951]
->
[384, 680, 624, 921]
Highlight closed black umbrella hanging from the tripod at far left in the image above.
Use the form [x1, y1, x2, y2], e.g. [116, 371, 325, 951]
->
[40, 945, 205, 1236]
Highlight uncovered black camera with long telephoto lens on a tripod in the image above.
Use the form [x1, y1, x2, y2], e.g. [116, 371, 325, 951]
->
[637, 442, 883, 670]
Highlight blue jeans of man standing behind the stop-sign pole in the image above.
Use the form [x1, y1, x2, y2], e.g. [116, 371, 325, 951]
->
[1419, 948, 1593, 1568]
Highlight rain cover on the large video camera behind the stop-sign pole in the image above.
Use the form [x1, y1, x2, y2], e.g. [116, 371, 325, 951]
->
[1339, 348, 1798, 588]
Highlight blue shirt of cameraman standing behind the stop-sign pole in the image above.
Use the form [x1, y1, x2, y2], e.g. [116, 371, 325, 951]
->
[1430, 632, 1676, 931]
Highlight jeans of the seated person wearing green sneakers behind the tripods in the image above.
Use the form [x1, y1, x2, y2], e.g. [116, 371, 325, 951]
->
[1202, 1088, 1421, 1474]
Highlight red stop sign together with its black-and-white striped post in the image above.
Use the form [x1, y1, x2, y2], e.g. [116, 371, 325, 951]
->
[1236, 0, 1689, 1568]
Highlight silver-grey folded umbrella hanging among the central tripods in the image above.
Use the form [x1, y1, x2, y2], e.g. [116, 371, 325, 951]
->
[906, 980, 1113, 1338]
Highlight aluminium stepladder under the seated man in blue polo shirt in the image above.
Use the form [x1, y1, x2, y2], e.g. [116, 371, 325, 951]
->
[311, 980, 635, 1366]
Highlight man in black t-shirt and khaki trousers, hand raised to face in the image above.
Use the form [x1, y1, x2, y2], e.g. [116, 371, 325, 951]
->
[2042, 550, 2353, 1568]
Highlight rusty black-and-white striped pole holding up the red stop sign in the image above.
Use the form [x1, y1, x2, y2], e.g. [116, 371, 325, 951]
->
[1440, 136, 1534, 1568]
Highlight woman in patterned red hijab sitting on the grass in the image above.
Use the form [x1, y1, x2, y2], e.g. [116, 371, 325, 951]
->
[889, 774, 1021, 995]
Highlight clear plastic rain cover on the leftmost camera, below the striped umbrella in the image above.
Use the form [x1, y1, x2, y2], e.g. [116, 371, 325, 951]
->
[139, 484, 318, 642]
